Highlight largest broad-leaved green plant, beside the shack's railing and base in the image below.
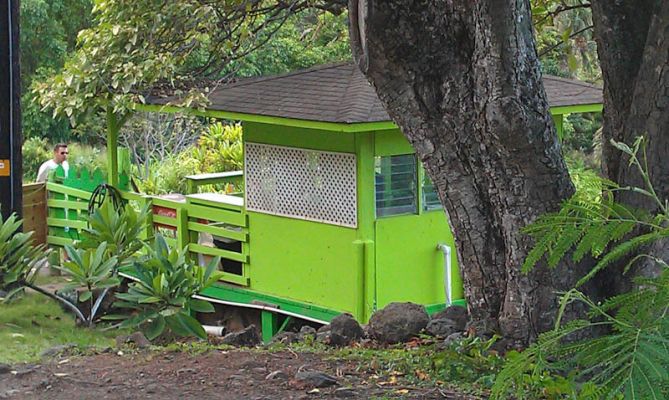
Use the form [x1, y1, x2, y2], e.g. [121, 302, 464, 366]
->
[115, 235, 221, 339]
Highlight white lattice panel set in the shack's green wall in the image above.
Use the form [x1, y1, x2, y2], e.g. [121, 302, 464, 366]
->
[244, 143, 358, 228]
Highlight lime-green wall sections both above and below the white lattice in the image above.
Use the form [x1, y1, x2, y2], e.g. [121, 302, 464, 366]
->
[244, 123, 364, 319]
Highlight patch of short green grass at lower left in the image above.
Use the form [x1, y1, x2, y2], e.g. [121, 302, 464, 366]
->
[0, 293, 120, 364]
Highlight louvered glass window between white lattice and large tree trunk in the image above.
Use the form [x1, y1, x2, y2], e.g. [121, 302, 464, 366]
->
[375, 154, 417, 217]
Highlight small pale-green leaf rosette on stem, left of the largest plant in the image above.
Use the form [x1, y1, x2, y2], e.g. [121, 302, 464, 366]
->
[56, 242, 121, 326]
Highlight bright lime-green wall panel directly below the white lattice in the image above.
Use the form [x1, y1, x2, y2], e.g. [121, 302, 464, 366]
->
[248, 212, 360, 313]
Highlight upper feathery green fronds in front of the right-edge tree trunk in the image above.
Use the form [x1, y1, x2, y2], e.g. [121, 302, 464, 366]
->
[523, 138, 669, 286]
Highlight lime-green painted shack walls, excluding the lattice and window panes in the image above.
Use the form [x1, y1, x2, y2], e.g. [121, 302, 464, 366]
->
[244, 123, 462, 321]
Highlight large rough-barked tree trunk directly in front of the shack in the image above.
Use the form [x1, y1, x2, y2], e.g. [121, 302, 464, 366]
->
[349, 0, 577, 343]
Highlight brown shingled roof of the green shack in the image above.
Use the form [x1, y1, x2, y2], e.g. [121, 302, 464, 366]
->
[151, 63, 602, 124]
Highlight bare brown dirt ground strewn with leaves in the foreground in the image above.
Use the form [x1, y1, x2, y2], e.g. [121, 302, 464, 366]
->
[0, 350, 474, 400]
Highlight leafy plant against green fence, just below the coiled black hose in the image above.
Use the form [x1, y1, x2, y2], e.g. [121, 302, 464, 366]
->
[77, 203, 150, 269]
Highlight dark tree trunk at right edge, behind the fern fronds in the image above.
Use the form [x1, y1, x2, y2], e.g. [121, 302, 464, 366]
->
[592, 0, 669, 280]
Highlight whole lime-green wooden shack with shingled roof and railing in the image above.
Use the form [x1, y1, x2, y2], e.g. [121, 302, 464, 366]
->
[52, 63, 602, 339]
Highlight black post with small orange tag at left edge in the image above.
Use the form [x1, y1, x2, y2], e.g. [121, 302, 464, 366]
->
[0, 0, 23, 218]
